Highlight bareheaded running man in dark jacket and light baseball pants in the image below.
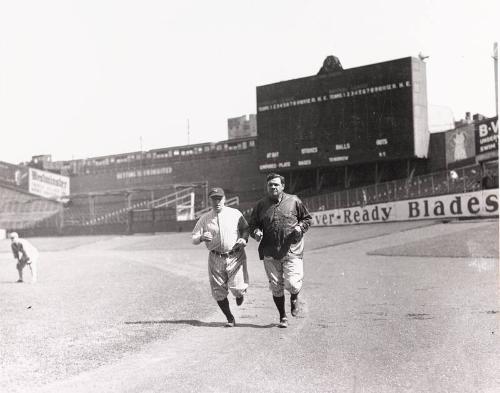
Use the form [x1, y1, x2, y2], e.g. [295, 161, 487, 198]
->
[250, 173, 312, 328]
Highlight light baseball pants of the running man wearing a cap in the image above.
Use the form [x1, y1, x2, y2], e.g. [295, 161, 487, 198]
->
[208, 250, 248, 301]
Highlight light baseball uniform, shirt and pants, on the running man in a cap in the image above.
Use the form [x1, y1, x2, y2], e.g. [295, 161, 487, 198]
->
[192, 206, 249, 301]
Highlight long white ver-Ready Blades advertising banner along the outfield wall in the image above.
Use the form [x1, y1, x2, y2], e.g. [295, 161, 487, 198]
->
[311, 190, 498, 226]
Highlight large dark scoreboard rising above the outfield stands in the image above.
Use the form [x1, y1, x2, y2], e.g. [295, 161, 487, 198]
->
[257, 57, 429, 171]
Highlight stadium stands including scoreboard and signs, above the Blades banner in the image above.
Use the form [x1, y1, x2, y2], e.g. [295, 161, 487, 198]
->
[0, 53, 498, 235]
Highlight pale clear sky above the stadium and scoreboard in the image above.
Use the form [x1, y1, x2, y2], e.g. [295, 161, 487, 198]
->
[0, 0, 500, 163]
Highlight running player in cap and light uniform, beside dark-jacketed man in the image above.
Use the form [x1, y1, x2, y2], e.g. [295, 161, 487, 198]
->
[192, 187, 249, 327]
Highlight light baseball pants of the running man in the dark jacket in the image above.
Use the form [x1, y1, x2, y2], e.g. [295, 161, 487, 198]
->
[264, 252, 304, 297]
